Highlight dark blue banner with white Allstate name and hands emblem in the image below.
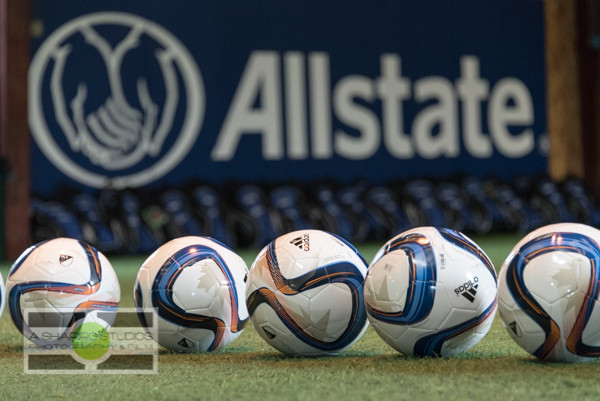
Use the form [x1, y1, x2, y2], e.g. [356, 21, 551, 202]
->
[29, 0, 547, 195]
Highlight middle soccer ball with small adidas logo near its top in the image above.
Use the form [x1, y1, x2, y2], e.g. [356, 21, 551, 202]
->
[246, 230, 368, 356]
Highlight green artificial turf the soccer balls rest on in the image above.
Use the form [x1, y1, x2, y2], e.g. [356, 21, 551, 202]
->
[0, 234, 600, 401]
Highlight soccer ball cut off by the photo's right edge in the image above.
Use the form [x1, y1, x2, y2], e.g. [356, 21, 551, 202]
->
[498, 223, 600, 362]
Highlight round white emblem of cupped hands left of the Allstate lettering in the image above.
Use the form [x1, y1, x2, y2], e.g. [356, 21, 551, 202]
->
[29, 12, 205, 188]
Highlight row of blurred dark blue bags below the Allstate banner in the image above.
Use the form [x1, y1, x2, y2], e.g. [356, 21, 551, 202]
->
[32, 176, 600, 254]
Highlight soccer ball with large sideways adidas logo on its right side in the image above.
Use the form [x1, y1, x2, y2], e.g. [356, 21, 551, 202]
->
[364, 227, 497, 357]
